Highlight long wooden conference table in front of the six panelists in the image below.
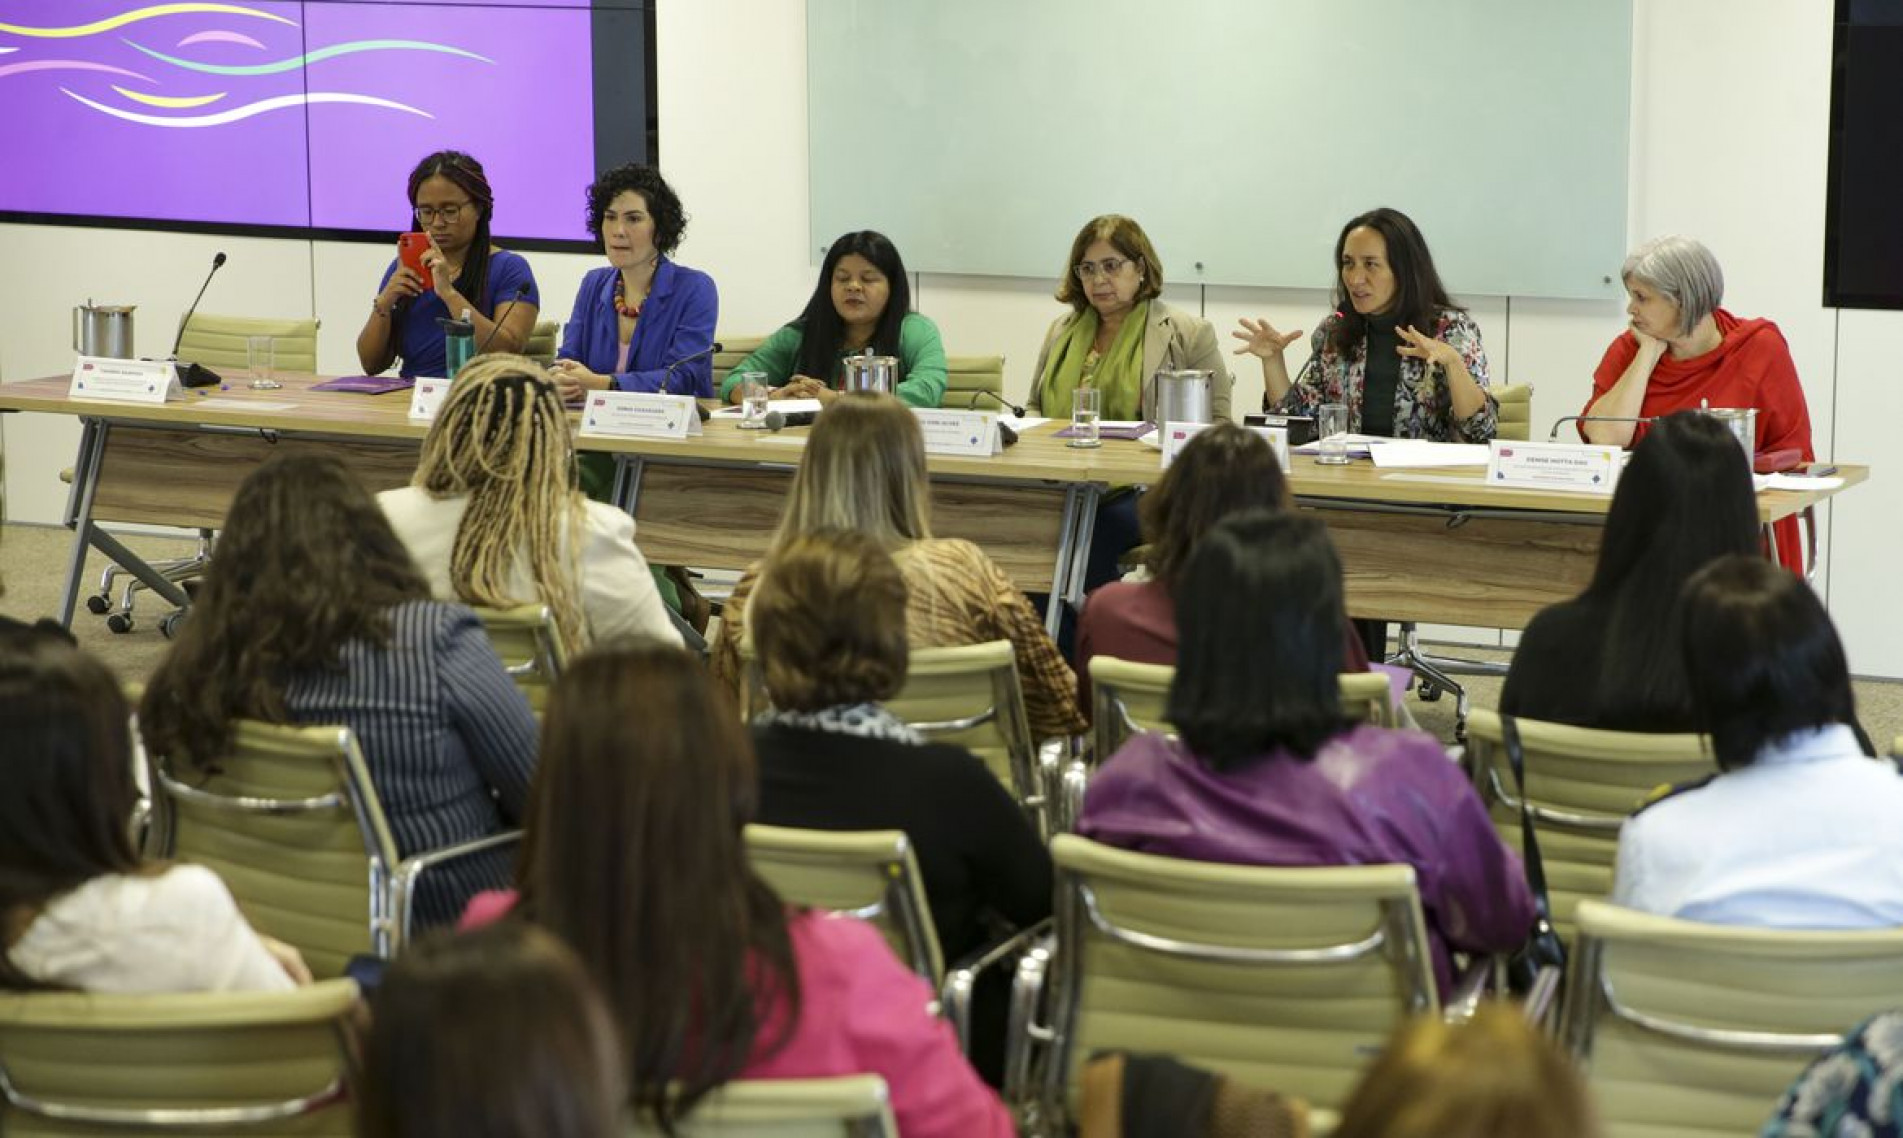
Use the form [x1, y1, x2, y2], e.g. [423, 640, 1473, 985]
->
[0, 375, 1869, 630]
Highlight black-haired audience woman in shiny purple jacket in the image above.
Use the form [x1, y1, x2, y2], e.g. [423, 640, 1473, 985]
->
[1077, 510, 1534, 991]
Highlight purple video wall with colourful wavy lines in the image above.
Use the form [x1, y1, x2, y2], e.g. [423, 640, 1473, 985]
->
[0, 0, 647, 240]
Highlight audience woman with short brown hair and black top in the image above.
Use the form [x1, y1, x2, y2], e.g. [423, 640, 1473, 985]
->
[748, 531, 1052, 1081]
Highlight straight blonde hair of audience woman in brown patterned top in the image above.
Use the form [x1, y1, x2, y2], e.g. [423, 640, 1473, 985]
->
[773, 392, 932, 554]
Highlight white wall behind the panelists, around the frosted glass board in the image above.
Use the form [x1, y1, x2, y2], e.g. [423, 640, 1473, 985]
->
[0, 0, 1903, 676]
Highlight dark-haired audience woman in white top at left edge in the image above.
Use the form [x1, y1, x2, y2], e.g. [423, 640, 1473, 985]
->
[0, 620, 310, 991]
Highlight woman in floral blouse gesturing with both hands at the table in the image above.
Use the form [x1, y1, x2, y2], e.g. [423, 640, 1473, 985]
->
[1235, 209, 1500, 443]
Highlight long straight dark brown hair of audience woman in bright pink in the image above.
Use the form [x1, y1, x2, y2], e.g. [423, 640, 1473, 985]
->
[518, 643, 799, 1132]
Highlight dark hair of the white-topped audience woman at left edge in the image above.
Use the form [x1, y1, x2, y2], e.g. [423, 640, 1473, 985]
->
[0, 622, 139, 990]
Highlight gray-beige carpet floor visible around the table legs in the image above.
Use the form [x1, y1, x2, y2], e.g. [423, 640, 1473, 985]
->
[11, 523, 1903, 748]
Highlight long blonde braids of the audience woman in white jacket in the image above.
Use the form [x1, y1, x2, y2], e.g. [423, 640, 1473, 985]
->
[411, 352, 588, 653]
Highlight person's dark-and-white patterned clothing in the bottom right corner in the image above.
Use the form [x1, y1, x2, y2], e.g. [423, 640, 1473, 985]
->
[1758, 1012, 1903, 1138]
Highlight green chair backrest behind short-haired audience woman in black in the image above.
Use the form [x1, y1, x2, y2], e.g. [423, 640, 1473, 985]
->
[746, 824, 946, 988]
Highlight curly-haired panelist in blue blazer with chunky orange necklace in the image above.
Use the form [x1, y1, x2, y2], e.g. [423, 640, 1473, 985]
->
[550, 164, 719, 402]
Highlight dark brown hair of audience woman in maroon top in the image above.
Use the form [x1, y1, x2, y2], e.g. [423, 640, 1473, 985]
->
[1138, 422, 1288, 586]
